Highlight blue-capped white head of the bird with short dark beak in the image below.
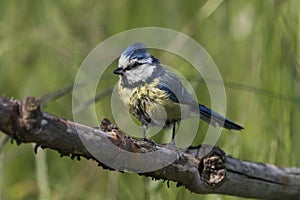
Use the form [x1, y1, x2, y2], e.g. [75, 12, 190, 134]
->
[114, 43, 160, 87]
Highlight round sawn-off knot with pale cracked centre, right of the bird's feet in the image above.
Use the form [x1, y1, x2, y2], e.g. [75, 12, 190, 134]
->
[198, 145, 226, 188]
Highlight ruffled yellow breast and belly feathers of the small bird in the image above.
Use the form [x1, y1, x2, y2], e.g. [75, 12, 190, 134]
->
[118, 81, 190, 126]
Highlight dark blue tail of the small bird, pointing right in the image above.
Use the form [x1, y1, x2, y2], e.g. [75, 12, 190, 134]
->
[199, 104, 244, 130]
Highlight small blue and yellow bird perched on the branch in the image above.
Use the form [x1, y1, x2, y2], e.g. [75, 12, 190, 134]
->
[113, 42, 244, 144]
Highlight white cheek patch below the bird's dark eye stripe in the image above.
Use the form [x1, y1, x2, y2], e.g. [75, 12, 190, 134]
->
[126, 64, 156, 84]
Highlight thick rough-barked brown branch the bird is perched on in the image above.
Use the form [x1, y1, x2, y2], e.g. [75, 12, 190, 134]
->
[0, 97, 300, 199]
